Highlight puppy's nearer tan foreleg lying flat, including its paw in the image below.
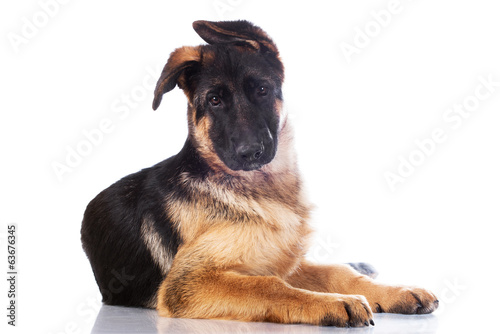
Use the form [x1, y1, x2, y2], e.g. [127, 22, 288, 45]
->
[158, 269, 373, 327]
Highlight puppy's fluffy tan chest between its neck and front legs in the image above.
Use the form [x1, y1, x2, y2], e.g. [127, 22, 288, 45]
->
[170, 183, 310, 276]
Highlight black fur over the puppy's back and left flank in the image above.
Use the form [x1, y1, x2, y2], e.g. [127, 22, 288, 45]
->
[81, 141, 208, 307]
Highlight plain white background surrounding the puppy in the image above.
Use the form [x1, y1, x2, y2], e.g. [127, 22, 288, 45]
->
[0, 0, 500, 333]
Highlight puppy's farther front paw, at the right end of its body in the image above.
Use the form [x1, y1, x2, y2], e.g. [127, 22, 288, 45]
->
[372, 287, 439, 314]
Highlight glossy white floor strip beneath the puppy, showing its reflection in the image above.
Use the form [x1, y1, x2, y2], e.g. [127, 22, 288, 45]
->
[92, 306, 438, 334]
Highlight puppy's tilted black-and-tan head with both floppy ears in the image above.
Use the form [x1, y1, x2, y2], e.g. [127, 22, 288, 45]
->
[153, 21, 284, 171]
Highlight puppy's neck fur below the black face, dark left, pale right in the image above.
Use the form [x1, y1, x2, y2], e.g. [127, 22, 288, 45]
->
[174, 114, 311, 227]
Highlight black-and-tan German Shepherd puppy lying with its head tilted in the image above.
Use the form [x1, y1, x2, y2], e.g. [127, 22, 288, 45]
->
[81, 21, 439, 327]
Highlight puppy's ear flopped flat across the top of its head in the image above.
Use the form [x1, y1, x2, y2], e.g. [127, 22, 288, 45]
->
[193, 20, 278, 55]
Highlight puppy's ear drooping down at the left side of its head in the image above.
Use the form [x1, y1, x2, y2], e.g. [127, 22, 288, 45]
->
[153, 46, 201, 110]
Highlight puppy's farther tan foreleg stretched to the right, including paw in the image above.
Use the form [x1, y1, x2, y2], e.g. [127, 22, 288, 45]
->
[287, 261, 439, 314]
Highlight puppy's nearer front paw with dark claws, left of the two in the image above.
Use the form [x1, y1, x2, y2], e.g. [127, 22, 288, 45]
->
[319, 295, 375, 327]
